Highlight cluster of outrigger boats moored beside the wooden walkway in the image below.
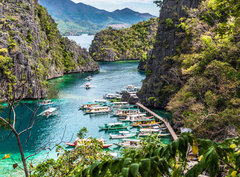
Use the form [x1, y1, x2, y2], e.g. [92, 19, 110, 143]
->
[75, 86, 170, 148]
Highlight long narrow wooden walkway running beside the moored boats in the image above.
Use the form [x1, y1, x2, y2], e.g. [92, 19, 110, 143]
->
[136, 103, 178, 141]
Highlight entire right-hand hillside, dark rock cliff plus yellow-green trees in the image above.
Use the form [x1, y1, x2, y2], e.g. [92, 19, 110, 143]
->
[139, 0, 240, 140]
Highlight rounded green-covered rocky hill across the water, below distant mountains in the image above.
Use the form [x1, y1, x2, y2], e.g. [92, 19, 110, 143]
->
[89, 18, 158, 61]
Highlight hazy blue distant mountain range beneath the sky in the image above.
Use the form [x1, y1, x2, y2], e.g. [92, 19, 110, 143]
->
[39, 0, 154, 35]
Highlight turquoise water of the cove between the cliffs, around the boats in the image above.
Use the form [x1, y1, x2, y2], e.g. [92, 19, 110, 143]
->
[0, 61, 169, 176]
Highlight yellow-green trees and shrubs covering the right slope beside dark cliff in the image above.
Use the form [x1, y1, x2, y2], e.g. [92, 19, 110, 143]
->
[161, 0, 240, 140]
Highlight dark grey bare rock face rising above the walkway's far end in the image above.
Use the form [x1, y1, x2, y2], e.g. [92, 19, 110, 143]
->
[138, 0, 199, 108]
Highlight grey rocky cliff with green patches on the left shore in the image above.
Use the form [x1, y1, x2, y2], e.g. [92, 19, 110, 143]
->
[0, 0, 99, 100]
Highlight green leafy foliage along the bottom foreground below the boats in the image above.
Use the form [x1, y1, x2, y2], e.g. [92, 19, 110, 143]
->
[34, 134, 240, 177]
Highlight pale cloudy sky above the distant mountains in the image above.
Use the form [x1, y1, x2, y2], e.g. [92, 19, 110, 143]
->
[72, 0, 159, 17]
